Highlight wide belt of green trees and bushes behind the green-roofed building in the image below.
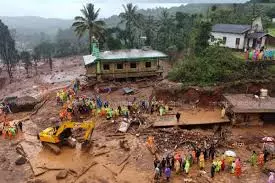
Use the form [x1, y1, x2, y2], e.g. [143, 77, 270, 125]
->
[2, 1, 275, 84]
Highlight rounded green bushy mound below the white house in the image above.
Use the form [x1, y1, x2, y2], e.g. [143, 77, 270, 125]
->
[168, 46, 245, 85]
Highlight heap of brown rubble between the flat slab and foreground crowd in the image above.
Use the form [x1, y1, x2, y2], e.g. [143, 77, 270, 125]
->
[142, 128, 215, 151]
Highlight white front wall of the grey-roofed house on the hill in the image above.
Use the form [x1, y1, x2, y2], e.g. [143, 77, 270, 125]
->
[211, 32, 245, 50]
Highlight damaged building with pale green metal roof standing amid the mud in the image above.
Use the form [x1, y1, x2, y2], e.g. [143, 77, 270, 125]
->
[83, 43, 168, 80]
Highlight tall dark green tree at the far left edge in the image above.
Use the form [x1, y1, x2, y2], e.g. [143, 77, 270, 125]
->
[0, 20, 18, 79]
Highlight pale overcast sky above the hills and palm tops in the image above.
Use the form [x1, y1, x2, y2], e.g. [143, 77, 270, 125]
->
[0, 0, 247, 19]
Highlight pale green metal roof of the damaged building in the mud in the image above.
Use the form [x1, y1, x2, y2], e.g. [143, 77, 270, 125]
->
[83, 49, 168, 65]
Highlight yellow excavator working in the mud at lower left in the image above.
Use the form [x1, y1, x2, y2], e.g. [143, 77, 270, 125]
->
[37, 122, 95, 154]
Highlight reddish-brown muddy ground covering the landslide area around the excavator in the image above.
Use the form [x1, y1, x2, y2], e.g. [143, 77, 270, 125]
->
[0, 57, 275, 183]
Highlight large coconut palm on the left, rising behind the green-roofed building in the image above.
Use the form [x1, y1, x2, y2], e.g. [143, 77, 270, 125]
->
[72, 3, 105, 53]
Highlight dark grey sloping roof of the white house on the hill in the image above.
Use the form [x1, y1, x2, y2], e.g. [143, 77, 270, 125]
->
[212, 24, 251, 34]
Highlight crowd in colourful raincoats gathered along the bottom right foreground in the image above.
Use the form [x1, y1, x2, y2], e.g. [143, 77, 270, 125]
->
[154, 145, 275, 183]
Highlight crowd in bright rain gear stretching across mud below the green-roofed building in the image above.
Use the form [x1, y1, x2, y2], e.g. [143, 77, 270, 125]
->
[56, 80, 169, 121]
